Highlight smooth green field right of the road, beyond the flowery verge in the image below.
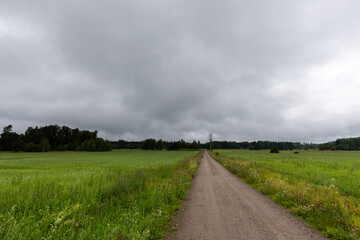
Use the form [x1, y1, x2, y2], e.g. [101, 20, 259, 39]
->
[220, 150, 360, 198]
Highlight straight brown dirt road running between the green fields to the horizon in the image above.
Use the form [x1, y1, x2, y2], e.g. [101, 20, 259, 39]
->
[165, 152, 324, 240]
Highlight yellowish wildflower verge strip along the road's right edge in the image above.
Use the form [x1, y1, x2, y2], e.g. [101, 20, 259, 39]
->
[209, 152, 360, 239]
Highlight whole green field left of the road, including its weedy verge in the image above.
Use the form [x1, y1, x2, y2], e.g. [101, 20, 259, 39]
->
[0, 150, 200, 239]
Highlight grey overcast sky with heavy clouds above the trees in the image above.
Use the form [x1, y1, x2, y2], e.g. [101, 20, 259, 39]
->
[0, 0, 360, 142]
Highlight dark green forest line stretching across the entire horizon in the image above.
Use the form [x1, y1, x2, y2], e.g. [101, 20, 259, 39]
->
[0, 125, 360, 152]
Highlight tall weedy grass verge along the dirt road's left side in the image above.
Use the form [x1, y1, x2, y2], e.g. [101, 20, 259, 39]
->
[0, 152, 203, 240]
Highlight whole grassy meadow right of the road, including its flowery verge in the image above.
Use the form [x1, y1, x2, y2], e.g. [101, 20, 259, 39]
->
[211, 150, 360, 239]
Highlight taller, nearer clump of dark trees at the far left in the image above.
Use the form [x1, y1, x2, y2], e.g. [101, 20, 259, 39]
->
[0, 125, 112, 152]
